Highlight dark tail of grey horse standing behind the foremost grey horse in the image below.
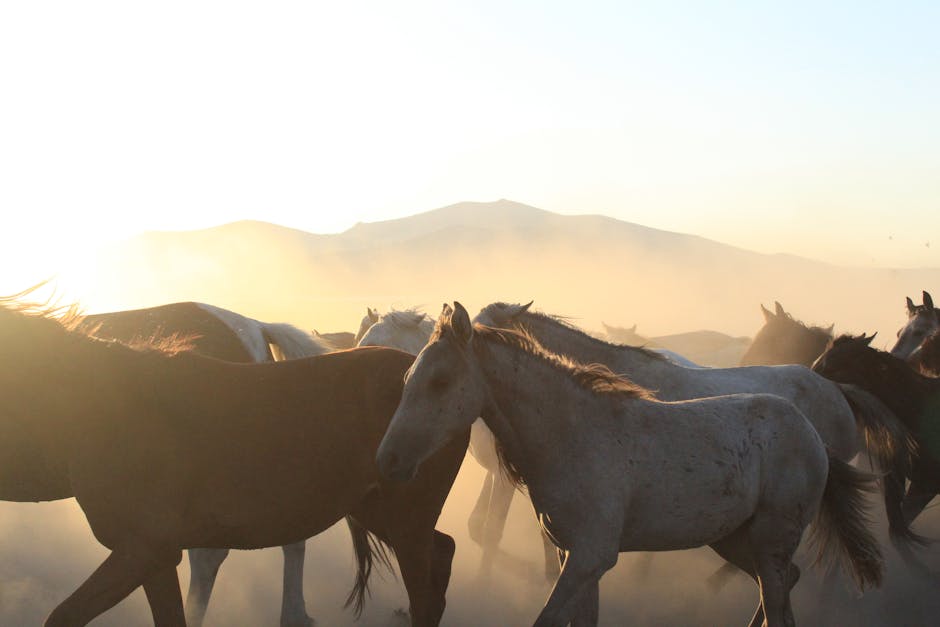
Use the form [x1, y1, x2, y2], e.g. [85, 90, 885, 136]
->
[839, 383, 928, 546]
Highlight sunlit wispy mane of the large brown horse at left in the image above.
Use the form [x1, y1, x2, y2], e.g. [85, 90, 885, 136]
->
[0, 281, 198, 355]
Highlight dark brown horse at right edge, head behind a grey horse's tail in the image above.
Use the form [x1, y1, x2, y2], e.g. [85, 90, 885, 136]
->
[813, 334, 940, 562]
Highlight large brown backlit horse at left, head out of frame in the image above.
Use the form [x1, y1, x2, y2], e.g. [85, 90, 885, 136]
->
[0, 293, 469, 627]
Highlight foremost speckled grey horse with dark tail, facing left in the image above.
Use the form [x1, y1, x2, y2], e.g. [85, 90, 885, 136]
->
[376, 303, 883, 627]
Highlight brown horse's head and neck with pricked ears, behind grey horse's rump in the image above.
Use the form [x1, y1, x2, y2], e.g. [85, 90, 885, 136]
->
[740, 301, 835, 367]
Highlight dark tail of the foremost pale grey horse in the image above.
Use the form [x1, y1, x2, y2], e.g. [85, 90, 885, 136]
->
[813, 453, 884, 590]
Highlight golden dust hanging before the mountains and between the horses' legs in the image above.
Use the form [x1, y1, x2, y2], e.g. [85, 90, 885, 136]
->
[0, 211, 940, 627]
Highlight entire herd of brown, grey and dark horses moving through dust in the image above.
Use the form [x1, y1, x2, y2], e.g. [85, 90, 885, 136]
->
[0, 290, 940, 627]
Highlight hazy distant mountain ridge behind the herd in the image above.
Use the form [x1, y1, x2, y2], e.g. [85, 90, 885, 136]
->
[81, 200, 940, 350]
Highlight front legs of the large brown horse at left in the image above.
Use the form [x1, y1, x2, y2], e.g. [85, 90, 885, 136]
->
[44, 547, 185, 627]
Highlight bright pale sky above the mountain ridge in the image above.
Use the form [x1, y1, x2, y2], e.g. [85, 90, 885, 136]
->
[0, 1, 940, 288]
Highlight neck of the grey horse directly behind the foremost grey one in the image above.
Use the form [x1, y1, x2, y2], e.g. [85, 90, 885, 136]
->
[521, 314, 670, 376]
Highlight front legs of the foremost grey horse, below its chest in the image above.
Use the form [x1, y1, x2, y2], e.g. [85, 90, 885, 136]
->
[533, 544, 618, 627]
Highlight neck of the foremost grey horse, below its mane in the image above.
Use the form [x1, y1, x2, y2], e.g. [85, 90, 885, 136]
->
[475, 341, 604, 482]
